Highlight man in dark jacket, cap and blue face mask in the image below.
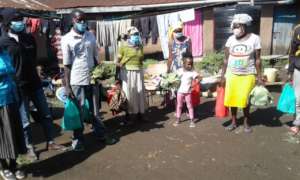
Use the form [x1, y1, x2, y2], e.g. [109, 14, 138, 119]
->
[0, 9, 64, 159]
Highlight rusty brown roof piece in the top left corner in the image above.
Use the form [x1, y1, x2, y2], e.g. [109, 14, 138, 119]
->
[0, 0, 54, 11]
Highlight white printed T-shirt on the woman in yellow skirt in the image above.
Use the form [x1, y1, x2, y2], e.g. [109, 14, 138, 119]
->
[225, 33, 261, 75]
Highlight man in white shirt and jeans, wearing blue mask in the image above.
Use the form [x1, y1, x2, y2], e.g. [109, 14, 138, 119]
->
[61, 10, 115, 151]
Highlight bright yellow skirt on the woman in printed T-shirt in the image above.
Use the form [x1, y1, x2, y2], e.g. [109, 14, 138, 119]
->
[224, 74, 255, 108]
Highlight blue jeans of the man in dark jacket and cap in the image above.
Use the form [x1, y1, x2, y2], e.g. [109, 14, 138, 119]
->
[19, 88, 54, 146]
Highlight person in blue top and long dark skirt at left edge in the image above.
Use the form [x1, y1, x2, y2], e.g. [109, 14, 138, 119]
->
[0, 52, 26, 180]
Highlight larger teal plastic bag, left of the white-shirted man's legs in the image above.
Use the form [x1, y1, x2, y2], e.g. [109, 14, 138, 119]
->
[61, 98, 82, 131]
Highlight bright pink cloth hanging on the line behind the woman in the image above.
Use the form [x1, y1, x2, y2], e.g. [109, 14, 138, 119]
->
[183, 10, 203, 56]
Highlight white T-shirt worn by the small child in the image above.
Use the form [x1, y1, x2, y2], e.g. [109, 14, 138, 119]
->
[177, 68, 198, 93]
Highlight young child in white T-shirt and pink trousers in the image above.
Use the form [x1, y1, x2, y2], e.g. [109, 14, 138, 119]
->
[173, 53, 200, 128]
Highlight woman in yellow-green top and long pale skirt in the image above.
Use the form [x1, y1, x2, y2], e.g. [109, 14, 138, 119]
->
[117, 27, 146, 120]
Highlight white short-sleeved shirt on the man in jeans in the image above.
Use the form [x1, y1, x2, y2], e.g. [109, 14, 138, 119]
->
[61, 29, 98, 86]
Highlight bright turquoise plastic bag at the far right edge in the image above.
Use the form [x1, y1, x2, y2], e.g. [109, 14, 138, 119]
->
[277, 83, 296, 114]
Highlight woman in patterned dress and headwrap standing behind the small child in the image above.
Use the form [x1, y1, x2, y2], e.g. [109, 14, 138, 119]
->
[168, 22, 192, 72]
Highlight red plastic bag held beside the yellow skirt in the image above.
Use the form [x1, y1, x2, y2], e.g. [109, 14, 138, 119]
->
[215, 86, 228, 118]
